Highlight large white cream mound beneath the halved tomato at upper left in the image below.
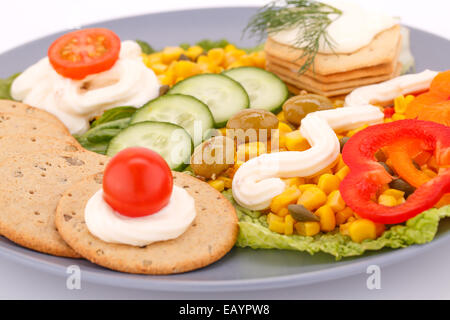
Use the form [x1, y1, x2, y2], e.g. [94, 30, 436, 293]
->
[11, 41, 160, 134]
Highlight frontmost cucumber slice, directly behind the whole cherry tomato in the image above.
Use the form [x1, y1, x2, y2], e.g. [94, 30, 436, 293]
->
[106, 121, 194, 171]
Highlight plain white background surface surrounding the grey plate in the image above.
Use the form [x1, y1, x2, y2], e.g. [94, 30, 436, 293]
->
[0, 0, 450, 299]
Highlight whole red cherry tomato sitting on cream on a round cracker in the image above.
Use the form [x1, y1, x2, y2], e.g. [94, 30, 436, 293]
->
[103, 147, 173, 217]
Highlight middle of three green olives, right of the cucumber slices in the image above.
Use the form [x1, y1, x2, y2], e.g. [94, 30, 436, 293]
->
[227, 109, 279, 141]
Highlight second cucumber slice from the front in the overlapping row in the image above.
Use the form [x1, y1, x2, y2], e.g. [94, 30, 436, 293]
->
[130, 94, 214, 146]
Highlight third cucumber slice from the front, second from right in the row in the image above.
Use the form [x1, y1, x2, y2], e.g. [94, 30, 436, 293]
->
[169, 73, 249, 128]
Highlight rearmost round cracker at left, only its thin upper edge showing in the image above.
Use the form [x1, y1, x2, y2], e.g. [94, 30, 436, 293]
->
[0, 100, 70, 134]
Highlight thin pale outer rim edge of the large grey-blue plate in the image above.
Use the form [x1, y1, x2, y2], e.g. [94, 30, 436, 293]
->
[0, 6, 450, 292]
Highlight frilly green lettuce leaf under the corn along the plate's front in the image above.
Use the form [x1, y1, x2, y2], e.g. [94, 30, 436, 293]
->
[223, 190, 450, 260]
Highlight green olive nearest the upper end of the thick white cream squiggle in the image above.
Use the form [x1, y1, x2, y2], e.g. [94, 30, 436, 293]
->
[283, 94, 334, 126]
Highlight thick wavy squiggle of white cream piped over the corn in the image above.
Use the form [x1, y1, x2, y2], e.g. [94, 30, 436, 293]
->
[232, 106, 384, 210]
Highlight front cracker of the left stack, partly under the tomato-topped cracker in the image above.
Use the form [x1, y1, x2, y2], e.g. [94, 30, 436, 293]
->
[0, 151, 108, 257]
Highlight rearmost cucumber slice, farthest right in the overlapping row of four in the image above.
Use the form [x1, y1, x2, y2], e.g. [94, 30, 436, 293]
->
[223, 67, 289, 113]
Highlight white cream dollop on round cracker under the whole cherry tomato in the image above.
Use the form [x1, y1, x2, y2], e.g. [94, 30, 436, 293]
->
[84, 186, 196, 247]
